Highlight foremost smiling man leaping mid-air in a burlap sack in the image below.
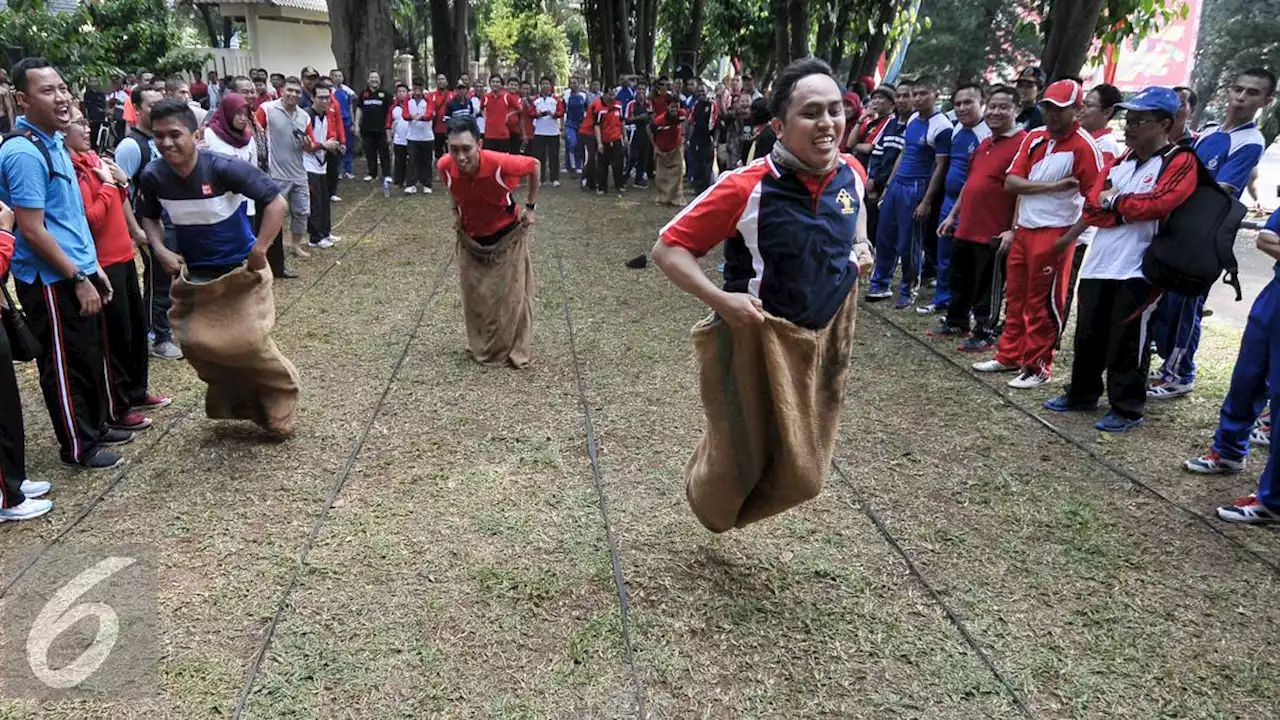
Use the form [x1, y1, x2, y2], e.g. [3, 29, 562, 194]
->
[653, 59, 873, 533]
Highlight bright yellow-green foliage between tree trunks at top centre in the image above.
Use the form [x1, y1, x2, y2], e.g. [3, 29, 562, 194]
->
[480, 0, 568, 85]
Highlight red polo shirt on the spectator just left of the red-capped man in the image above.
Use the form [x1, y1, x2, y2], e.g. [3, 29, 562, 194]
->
[956, 129, 1027, 243]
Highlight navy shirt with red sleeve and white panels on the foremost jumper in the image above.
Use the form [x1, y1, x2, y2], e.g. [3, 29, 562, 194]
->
[659, 155, 867, 329]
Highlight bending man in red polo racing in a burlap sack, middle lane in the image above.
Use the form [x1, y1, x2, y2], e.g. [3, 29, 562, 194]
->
[438, 117, 541, 368]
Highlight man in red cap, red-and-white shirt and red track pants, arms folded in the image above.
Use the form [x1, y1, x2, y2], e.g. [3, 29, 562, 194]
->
[973, 79, 1102, 389]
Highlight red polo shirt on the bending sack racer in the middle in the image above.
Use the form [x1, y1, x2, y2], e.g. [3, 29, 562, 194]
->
[436, 148, 538, 238]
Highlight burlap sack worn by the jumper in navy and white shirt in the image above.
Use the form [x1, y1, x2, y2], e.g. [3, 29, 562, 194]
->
[169, 262, 298, 437]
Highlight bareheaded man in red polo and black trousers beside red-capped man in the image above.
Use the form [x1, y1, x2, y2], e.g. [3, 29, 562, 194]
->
[938, 86, 1027, 352]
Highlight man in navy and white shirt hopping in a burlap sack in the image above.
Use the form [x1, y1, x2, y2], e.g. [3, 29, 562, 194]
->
[138, 100, 298, 437]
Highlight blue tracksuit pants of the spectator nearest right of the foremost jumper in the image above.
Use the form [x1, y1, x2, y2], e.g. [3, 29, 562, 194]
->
[870, 178, 929, 299]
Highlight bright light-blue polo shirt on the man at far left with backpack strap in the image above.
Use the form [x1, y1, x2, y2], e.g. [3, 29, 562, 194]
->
[0, 117, 97, 284]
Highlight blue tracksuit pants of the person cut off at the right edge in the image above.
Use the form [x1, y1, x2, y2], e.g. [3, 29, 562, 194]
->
[1213, 272, 1280, 471]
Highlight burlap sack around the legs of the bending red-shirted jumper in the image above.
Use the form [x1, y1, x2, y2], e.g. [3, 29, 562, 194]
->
[458, 224, 536, 368]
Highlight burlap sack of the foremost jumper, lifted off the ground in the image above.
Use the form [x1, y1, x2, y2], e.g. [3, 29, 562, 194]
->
[685, 286, 858, 533]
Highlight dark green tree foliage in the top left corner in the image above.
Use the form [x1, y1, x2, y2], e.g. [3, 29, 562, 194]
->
[0, 0, 206, 85]
